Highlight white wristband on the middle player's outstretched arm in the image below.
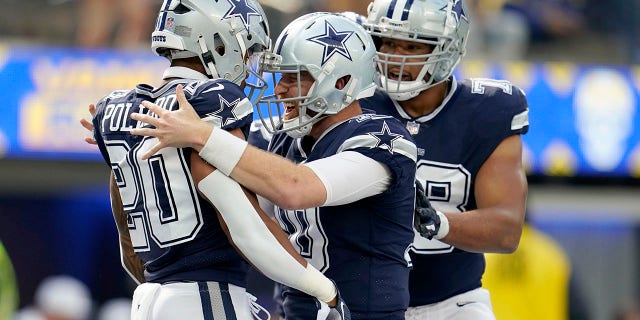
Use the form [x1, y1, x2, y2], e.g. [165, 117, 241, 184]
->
[198, 128, 247, 176]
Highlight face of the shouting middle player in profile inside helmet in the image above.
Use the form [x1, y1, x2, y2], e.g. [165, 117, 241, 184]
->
[274, 72, 315, 120]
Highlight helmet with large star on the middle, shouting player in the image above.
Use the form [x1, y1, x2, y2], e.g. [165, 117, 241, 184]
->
[258, 12, 376, 137]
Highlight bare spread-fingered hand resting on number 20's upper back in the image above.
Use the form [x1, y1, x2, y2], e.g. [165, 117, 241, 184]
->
[131, 85, 213, 160]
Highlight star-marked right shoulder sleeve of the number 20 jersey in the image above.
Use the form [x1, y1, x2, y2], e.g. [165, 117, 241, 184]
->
[185, 79, 253, 133]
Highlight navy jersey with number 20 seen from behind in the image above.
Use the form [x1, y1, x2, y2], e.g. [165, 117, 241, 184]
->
[93, 79, 253, 287]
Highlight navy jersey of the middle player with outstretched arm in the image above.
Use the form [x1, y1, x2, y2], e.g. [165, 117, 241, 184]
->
[269, 114, 416, 320]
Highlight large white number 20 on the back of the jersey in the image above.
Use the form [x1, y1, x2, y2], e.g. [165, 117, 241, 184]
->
[107, 138, 203, 252]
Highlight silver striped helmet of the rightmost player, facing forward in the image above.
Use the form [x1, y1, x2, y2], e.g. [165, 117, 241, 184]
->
[363, 0, 469, 101]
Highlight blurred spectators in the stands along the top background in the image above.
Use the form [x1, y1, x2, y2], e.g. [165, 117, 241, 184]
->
[0, 0, 640, 64]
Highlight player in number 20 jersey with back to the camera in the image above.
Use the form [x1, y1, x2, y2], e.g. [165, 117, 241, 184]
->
[83, 0, 349, 319]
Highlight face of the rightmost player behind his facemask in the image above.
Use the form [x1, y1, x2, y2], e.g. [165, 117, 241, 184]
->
[378, 38, 434, 81]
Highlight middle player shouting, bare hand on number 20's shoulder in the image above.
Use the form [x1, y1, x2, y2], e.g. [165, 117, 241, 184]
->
[132, 13, 416, 320]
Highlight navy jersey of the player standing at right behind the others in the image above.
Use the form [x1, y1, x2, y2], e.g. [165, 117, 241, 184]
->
[361, 78, 529, 306]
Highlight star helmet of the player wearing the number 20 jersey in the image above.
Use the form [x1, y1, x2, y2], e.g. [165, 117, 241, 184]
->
[151, 0, 271, 89]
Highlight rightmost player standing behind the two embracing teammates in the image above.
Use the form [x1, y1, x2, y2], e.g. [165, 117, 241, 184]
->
[362, 0, 529, 320]
